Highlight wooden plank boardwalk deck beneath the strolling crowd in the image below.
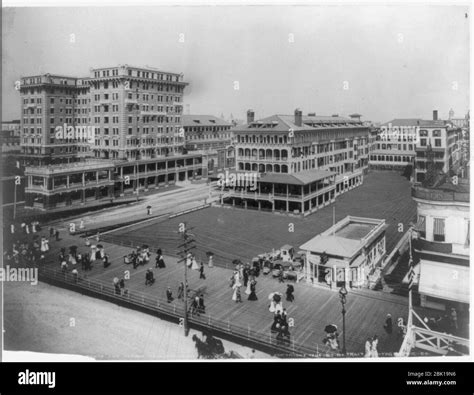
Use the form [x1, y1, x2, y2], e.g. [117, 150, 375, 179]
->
[31, 229, 436, 357]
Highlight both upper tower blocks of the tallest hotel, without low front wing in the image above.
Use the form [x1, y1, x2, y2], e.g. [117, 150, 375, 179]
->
[19, 65, 187, 165]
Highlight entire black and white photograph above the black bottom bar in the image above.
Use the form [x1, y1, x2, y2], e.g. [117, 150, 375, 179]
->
[0, 1, 472, 378]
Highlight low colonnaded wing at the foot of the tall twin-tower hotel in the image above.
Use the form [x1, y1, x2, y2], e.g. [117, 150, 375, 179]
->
[25, 154, 203, 211]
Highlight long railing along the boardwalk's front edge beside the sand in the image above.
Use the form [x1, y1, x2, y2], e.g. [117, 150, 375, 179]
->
[38, 266, 337, 358]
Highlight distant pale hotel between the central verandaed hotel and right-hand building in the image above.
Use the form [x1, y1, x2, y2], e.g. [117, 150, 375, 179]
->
[369, 119, 420, 170]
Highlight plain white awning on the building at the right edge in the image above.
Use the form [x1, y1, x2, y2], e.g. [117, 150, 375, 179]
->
[418, 259, 469, 303]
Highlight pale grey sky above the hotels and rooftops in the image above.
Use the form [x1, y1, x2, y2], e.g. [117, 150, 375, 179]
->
[2, 4, 471, 122]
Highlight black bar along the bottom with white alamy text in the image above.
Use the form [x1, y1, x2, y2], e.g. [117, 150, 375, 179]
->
[0, 361, 474, 395]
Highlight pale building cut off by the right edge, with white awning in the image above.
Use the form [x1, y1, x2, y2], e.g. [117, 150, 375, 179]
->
[412, 177, 470, 313]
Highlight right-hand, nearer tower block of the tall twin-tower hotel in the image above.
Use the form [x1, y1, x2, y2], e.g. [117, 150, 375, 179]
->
[88, 65, 187, 160]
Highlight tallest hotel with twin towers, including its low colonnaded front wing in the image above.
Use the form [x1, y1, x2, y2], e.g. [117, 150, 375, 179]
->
[20, 65, 203, 210]
